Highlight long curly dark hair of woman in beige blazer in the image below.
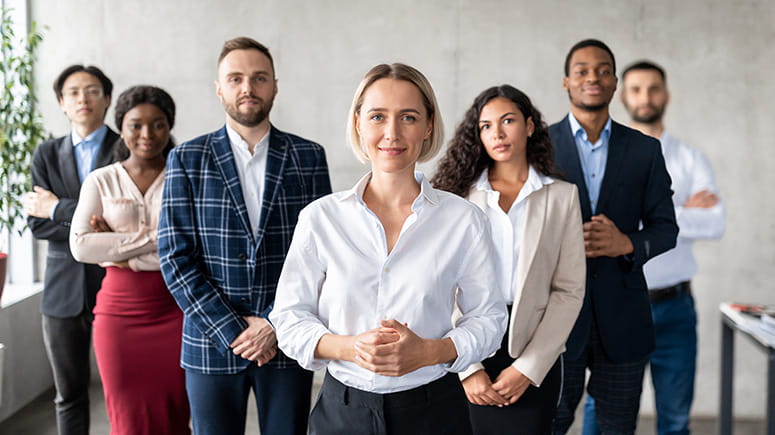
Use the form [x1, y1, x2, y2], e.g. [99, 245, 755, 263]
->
[431, 85, 559, 196]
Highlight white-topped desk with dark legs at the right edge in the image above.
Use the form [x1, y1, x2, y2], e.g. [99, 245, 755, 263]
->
[719, 303, 775, 435]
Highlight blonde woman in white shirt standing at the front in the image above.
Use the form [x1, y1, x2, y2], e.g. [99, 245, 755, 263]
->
[270, 64, 506, 435]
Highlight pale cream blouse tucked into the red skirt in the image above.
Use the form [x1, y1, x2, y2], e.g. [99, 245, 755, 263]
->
[70, 162, 164, 270]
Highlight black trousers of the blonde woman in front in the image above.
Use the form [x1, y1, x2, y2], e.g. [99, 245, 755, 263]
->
[309, 373, 471, 435]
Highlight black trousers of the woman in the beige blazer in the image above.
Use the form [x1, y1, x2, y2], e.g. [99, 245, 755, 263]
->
[468, 306, 562, 435]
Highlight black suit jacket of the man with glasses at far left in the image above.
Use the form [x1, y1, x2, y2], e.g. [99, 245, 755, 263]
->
[27, 128, 118, 318]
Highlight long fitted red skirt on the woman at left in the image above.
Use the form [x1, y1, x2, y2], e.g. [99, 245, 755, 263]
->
[94, 267, 191, 435]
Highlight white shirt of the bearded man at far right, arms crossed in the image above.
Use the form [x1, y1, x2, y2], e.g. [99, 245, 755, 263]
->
[643, 133, 725, 289]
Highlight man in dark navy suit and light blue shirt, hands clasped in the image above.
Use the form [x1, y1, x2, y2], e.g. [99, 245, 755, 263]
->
[549, 39, 678, 434]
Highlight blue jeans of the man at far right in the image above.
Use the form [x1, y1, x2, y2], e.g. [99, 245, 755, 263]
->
[582, 293, 697, 435]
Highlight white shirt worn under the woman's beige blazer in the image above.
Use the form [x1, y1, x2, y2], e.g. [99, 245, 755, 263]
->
[474, 166, 554, 305]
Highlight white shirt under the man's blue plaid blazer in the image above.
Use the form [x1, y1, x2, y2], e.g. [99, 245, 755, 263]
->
[226, 124, 271, 234]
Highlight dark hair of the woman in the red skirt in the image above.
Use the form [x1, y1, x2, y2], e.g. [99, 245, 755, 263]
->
[113, 86, 175, 161]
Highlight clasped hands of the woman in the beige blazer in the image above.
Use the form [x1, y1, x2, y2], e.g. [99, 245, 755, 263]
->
[463, 366, 530, 406]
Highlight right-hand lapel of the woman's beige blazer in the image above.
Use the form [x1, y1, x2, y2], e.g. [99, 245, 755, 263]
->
[514, 185, 551, 305]
